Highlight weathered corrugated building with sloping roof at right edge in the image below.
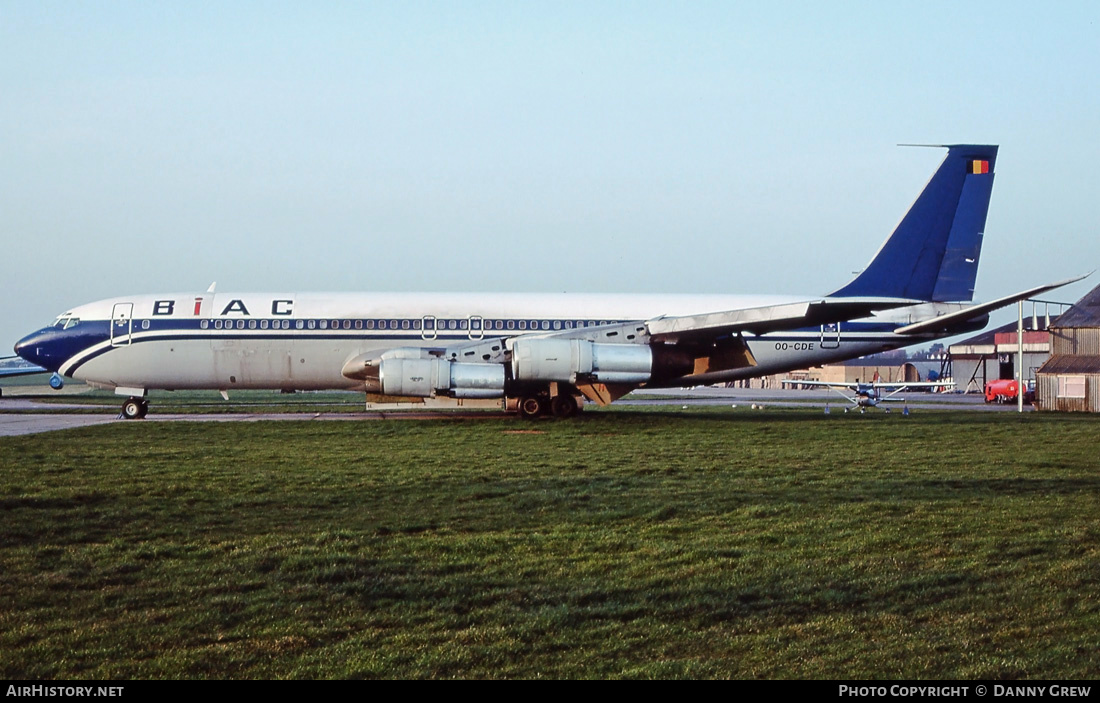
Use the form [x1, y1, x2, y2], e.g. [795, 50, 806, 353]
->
[1035, 286, 1100, 413]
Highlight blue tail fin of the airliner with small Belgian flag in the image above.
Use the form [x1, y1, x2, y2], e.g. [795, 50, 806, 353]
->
[832, 144, 997, 303]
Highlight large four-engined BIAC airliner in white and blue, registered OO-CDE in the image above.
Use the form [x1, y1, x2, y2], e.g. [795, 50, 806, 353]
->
[15, 144, 1076, 418]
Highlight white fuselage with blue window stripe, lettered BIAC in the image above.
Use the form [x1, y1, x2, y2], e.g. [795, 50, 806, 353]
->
[45, 293, 946, 389]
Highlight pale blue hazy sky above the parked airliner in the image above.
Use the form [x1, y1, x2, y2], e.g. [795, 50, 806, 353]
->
[0, 0, 1100, 347]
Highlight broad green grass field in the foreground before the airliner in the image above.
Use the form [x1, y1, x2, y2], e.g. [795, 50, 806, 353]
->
[0, 410, 1100, 679]
